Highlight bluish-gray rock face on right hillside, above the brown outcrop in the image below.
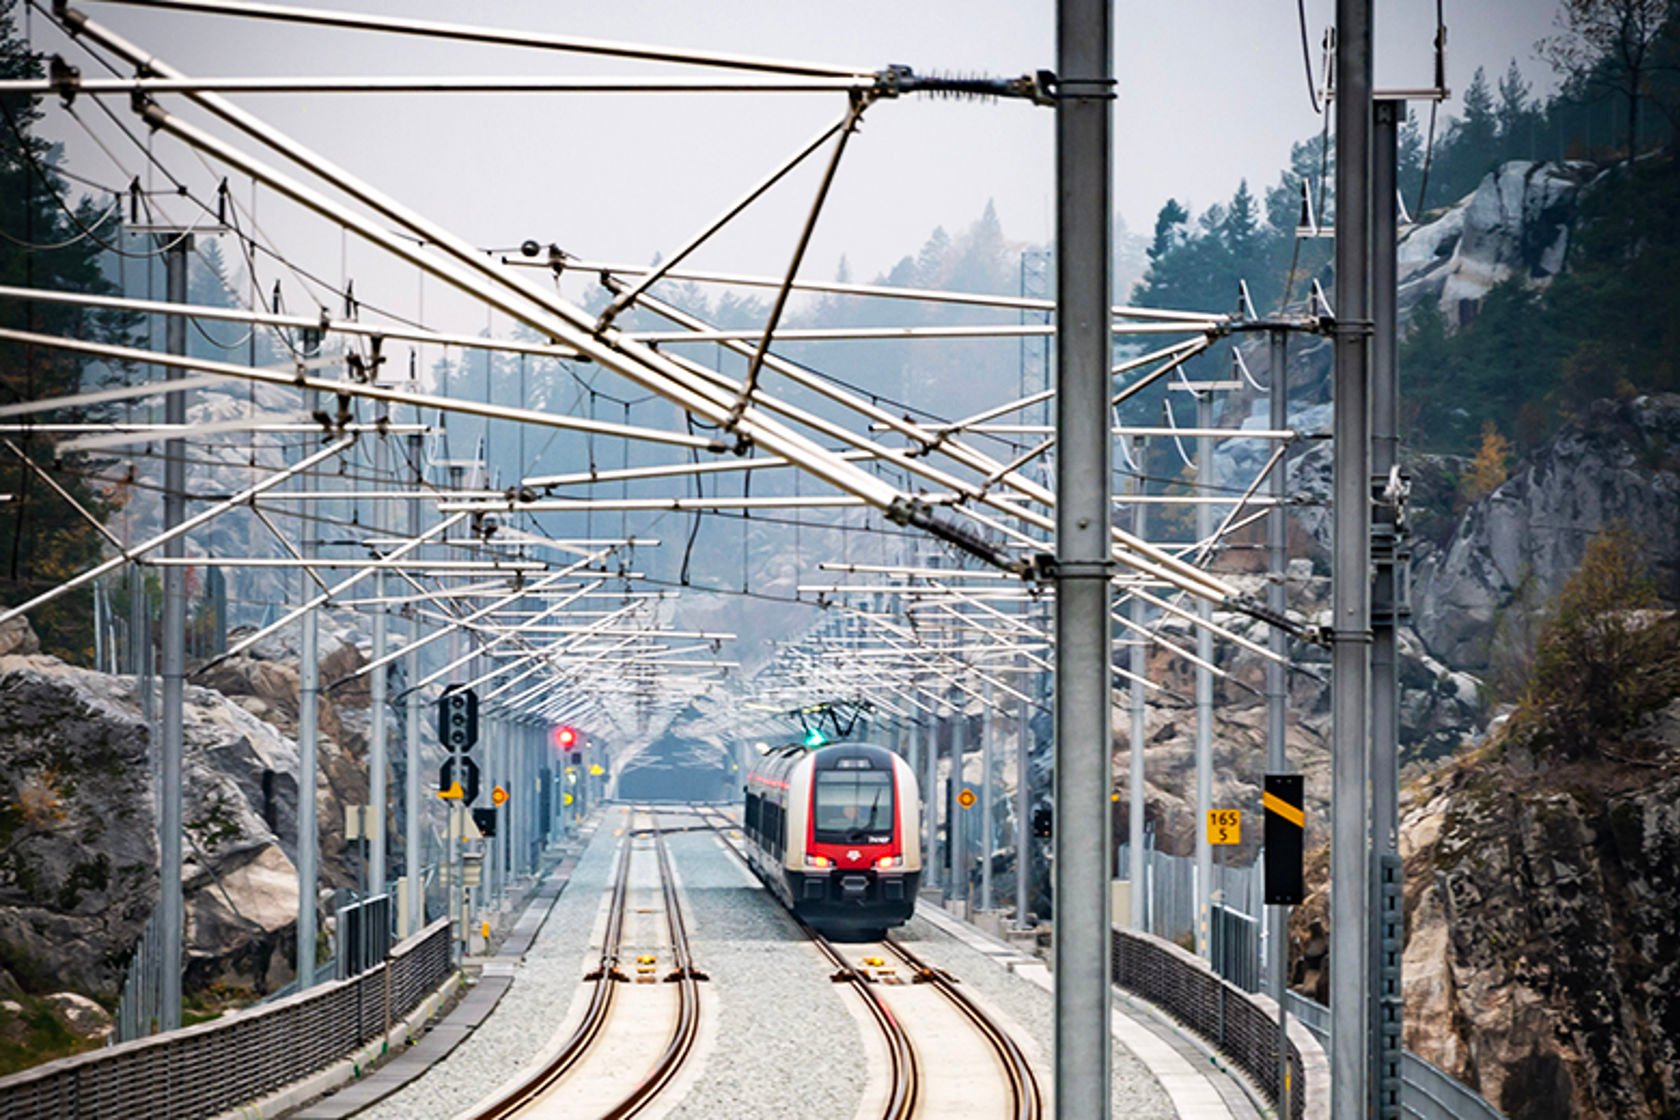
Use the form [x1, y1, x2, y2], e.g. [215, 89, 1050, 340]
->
[1413, 395, 1680, 672]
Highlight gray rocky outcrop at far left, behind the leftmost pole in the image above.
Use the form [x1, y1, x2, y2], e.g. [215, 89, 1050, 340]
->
[0, 644, 312, 999]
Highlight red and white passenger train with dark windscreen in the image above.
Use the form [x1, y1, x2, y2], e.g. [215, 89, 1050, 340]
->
[746, 742, 922, 935]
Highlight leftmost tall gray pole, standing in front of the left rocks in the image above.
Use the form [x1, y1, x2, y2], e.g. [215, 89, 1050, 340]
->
[157, 233, 193, 1031]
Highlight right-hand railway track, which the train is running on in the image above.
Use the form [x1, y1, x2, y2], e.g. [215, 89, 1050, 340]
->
[692, 804, 1045, 1120]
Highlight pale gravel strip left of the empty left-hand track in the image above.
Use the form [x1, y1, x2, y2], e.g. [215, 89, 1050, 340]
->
[358, 808, 623, 1120]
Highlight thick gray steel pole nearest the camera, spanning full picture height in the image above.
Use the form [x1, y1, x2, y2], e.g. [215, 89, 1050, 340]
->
[1053, 0, 1114, 1120]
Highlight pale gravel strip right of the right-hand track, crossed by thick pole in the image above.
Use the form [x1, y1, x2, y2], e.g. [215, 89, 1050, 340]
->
[894, 917, 1178, 1120]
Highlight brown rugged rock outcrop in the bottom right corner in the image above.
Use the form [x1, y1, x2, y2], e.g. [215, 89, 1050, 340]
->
[1401, 704, 1680, 1120]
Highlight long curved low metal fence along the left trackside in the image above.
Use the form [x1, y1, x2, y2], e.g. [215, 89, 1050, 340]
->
[0, 920, 454, 1120]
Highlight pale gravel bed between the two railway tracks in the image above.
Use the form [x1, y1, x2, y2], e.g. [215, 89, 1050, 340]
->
[670, 822, 865, 1120]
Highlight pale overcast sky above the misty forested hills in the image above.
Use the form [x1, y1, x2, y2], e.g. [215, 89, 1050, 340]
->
[35, 0, 1557, 329]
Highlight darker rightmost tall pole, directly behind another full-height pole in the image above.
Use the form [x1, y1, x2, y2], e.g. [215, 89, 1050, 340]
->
[1369, 99, 1406, 1120]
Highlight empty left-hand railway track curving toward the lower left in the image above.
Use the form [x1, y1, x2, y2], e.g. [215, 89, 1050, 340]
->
[472, 826, 706, 1120]
